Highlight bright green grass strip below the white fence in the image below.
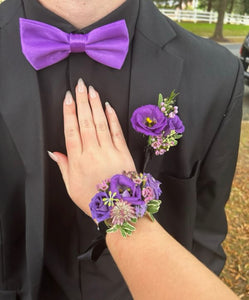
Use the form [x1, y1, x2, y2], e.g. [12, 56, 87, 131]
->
[178, 22, 249, 39]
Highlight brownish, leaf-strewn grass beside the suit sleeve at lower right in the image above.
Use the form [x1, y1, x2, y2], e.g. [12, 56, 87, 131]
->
[220, 121, 249, 300]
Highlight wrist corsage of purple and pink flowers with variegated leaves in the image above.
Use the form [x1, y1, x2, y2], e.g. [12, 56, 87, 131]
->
[89, 172, 162, 237]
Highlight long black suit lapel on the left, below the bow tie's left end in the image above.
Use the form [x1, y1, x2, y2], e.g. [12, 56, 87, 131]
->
[0, 10, 44, 299]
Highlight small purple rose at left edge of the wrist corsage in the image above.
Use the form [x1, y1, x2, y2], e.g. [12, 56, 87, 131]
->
[89, 192, 111, 222]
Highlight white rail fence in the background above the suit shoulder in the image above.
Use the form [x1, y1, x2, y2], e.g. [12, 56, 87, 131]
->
[160, 9, 249, 25]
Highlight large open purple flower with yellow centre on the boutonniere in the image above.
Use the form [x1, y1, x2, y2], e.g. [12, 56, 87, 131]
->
[131, 104, 168, 136]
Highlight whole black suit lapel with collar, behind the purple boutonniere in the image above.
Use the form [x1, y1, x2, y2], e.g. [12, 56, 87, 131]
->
[128, 0, 183, 171]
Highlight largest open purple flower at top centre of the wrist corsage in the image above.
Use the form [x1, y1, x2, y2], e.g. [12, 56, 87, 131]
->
[110, 174, 144, 205]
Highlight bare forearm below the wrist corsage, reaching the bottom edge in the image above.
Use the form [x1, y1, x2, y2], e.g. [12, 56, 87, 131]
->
[106, 218, 237, 300]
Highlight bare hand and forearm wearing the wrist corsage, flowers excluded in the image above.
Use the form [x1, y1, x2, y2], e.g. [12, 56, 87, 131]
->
[50, 80, 238, 300]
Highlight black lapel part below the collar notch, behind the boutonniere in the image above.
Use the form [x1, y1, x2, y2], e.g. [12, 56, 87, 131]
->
[128, 32, 183, 172]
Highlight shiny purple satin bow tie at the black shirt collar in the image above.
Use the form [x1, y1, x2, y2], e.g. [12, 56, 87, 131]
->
[20, 18, 129, 70]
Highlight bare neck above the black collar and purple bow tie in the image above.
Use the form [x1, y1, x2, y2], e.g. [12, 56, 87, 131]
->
[38, 0, 126, 29]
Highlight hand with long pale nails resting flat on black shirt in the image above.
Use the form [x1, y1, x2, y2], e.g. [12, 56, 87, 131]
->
[49, 79, 135, 216]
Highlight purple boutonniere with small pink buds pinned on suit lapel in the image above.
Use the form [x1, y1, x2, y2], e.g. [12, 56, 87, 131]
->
[131, 91, 185, 155]
